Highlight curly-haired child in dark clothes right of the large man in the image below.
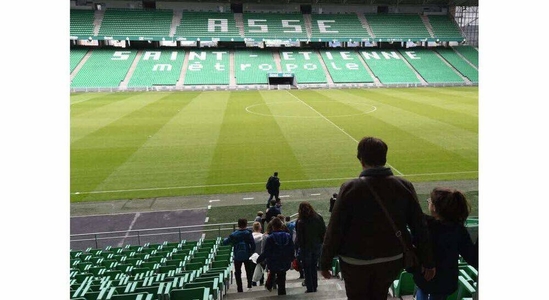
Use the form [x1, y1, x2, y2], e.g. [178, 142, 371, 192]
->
[414, 188, 478, 300]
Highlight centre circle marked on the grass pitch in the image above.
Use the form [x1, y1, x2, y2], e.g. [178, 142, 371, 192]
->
[246, 101, 377, 119]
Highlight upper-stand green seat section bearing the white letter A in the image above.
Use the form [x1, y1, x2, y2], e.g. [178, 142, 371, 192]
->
[175, 12, 242, 41]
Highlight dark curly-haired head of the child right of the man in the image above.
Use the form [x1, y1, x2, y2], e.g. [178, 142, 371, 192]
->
[429, 188, 471, 224]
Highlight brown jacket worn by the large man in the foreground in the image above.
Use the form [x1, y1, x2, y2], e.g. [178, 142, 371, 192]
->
[320, 167, 434, 270]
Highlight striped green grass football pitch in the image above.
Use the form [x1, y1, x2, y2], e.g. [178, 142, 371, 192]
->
[70, 87, 478, 202]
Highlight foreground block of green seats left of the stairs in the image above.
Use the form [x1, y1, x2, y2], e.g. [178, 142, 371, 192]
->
[70, 238, 227, 300]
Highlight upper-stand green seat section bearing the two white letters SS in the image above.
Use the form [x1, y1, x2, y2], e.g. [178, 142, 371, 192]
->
[243, 13, 308, 40]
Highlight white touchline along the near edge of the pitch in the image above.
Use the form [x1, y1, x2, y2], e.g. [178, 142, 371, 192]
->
[71, 171, 478, 195]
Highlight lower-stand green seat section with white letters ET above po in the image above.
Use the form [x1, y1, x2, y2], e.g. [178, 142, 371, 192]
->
[280, 50, 326, 83]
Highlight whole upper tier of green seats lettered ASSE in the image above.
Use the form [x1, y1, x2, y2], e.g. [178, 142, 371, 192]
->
[70, 8, 463, 41]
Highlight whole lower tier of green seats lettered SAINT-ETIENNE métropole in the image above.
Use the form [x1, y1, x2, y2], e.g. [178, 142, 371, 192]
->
[71, 47, 478, 88]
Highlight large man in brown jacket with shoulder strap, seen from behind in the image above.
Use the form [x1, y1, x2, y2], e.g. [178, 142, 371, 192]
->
[320, 137, 436, 300]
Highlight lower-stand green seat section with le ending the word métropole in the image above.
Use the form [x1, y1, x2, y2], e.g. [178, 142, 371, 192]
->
[320, 50, 374, 83]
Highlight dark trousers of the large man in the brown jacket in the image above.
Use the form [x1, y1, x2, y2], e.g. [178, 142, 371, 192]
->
[340, 259, 402, 300]
